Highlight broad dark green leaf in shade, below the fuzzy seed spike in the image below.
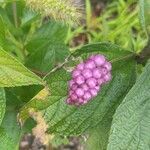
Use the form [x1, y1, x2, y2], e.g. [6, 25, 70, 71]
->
[26, 22, 69, 72]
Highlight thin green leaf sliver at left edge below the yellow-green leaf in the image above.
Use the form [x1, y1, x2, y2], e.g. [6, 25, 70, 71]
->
[0, 88, 6, 125]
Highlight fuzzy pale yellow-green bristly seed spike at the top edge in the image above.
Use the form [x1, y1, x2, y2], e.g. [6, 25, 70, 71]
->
[25, 0, 82, 24]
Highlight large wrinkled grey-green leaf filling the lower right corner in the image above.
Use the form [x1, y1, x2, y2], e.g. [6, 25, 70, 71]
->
[108, 62, 150, 150]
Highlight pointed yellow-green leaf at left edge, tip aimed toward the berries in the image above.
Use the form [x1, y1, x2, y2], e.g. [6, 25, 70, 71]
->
[0, 49, 43, 87]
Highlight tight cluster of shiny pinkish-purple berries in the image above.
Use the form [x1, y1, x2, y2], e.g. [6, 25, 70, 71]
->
[66, 54, 112, 106]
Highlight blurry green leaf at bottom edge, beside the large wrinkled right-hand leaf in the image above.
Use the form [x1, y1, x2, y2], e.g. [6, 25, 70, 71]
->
[85, 101, 119, 150]
